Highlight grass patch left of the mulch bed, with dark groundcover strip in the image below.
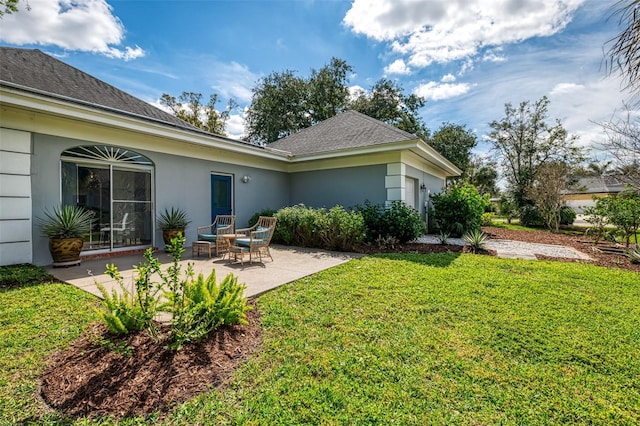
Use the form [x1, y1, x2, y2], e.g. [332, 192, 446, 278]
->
[0, 265, 97, 424]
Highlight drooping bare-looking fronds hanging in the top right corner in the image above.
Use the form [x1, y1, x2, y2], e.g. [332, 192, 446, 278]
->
[607, 0, 640, 92]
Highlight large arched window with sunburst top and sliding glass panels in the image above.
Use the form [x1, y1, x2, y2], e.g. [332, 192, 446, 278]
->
[60, 145, 154, 251]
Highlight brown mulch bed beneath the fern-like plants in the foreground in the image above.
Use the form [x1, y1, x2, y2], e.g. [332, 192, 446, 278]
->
[40, 308, 262, 418]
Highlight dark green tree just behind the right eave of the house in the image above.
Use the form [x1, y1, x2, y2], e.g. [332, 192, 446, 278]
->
[429, 123, 482, 177]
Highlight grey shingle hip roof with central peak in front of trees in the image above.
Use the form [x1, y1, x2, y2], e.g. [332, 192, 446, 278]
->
[269, 110, 418, 155]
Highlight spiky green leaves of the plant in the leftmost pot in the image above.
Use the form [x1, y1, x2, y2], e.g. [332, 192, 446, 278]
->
[37, 205, 93, 239]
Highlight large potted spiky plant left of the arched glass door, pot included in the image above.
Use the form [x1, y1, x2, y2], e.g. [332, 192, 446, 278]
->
[37, 205, 93, 266]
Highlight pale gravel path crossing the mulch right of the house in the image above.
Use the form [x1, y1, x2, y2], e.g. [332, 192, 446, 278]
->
[416, 235, 592, 260]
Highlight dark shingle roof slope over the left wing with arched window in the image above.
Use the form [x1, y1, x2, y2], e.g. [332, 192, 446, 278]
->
[0, 47, 195, 129]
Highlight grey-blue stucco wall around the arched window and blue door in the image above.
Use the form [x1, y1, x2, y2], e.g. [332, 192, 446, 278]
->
[31, 134, 289, 265]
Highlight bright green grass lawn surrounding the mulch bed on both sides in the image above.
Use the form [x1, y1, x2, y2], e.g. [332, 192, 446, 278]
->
[0, 254, 640, 425]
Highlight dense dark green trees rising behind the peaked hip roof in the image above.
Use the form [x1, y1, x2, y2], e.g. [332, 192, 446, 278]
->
[245, 58, 429, 143]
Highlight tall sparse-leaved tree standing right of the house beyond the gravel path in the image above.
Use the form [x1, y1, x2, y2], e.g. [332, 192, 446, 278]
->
[489, 96, 583, 207]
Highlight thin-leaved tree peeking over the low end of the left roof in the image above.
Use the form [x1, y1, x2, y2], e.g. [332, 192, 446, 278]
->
[160, 92, 236, 136]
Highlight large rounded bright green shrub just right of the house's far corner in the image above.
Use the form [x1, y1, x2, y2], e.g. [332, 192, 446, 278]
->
[432, 183, 485, 237]
